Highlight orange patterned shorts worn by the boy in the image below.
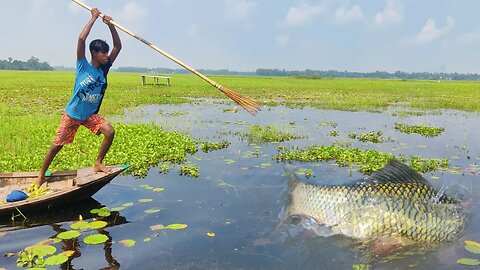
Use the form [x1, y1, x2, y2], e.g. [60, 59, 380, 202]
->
[53, 113, 108, 145]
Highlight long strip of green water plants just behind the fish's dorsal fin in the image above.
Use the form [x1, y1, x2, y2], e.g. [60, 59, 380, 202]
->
[273, 144, 448, 174]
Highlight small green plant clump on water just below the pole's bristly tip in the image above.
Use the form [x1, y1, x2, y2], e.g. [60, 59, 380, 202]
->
[240, 125, 303, 143]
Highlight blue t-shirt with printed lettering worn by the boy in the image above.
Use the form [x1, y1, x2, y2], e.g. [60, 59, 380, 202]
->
[65, 58, 112, 121]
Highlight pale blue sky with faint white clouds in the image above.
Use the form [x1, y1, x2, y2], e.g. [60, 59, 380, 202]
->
[0, 0, 480, 73]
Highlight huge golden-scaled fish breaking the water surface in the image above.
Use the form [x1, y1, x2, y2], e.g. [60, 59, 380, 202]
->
[285, 160, 466, 244]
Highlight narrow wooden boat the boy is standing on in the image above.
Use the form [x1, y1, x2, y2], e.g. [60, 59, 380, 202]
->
[0, 165, 130, 216]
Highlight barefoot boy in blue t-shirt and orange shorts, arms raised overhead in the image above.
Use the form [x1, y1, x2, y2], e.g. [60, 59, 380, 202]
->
[35, 8, 122, 186]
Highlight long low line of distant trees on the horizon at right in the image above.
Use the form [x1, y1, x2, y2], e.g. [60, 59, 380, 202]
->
[255, 68, 480, 80]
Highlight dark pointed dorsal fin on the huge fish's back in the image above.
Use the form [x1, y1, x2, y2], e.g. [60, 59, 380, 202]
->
[368, 159, 430, 187]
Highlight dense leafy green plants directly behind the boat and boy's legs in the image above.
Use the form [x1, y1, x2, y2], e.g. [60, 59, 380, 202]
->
[0, 122, 198, 177]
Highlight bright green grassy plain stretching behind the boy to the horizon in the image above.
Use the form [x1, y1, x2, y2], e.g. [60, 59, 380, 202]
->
[0, 71, 480, 171]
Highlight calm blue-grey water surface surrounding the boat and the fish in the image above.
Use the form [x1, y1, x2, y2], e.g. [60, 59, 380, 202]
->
[0, 100, 480, 269]
